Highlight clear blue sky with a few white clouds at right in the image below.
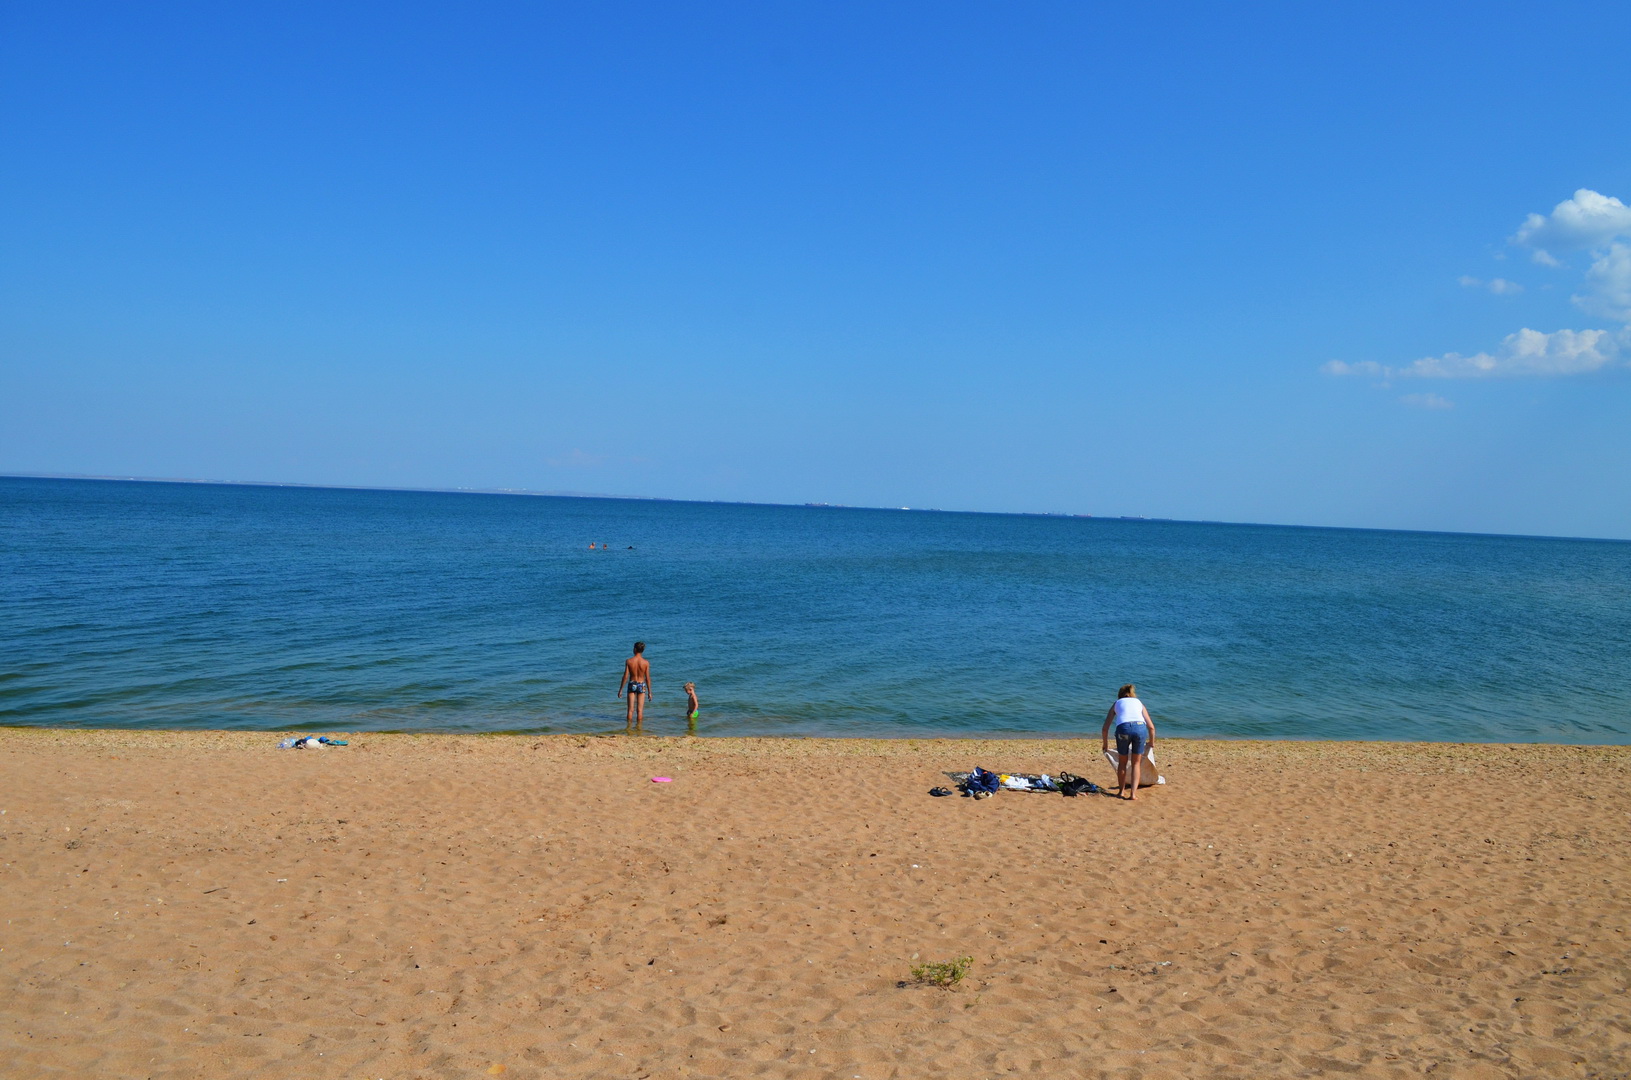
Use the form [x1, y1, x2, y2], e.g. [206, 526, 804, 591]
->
[0, 0, 1631, 538]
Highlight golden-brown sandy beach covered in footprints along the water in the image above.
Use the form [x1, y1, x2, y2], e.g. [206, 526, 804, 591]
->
[0, 731, 1631, 1080]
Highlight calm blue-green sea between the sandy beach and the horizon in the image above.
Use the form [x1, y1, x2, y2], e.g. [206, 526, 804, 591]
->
[0, 478, 1631, 742]
